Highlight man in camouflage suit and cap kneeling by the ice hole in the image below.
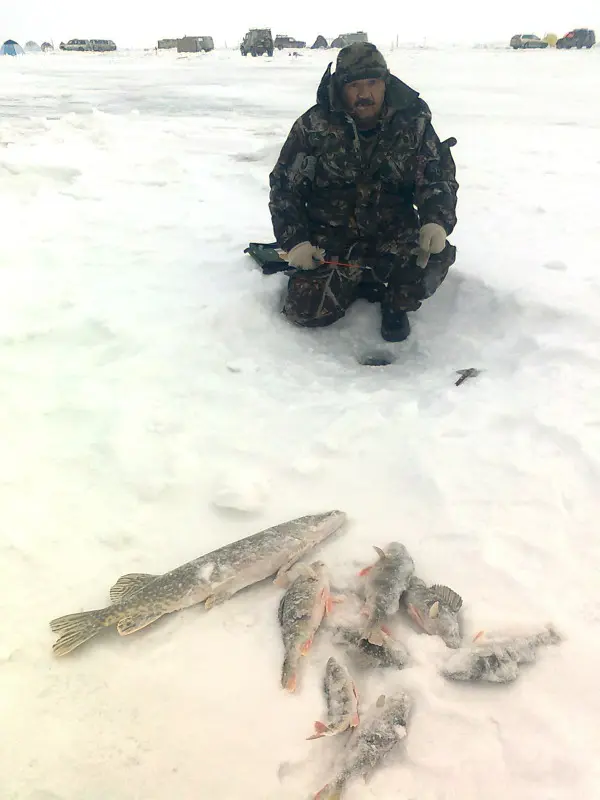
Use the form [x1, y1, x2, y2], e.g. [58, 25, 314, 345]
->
[269, 42, 458, 342]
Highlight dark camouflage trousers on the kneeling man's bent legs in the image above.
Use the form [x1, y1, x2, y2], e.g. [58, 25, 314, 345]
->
[283, 242, 456, 328]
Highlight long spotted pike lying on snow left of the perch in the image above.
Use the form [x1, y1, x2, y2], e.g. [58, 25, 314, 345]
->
[50, 511, 346, 656]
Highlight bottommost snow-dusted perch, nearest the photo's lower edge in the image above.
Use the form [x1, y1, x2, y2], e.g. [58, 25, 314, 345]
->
[314, 692, 411, 800]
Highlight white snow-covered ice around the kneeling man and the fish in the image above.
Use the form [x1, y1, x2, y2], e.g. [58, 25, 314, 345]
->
[0, 48, 600, 800]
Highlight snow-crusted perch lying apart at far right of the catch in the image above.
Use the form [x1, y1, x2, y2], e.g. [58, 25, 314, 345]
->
[441, 625, 561, 683]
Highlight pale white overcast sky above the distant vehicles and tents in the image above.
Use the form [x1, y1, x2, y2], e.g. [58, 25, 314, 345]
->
[0, 0, 600, 47]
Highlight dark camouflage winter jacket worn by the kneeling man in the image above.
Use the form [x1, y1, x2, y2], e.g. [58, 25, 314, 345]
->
[269, 64, 458, 258]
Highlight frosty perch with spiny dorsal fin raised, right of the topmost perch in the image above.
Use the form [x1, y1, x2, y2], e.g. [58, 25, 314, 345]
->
[401, 575, 462, 647]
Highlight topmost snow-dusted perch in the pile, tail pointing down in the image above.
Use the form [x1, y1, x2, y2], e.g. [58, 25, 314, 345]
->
[360, 542, 415, 645]
